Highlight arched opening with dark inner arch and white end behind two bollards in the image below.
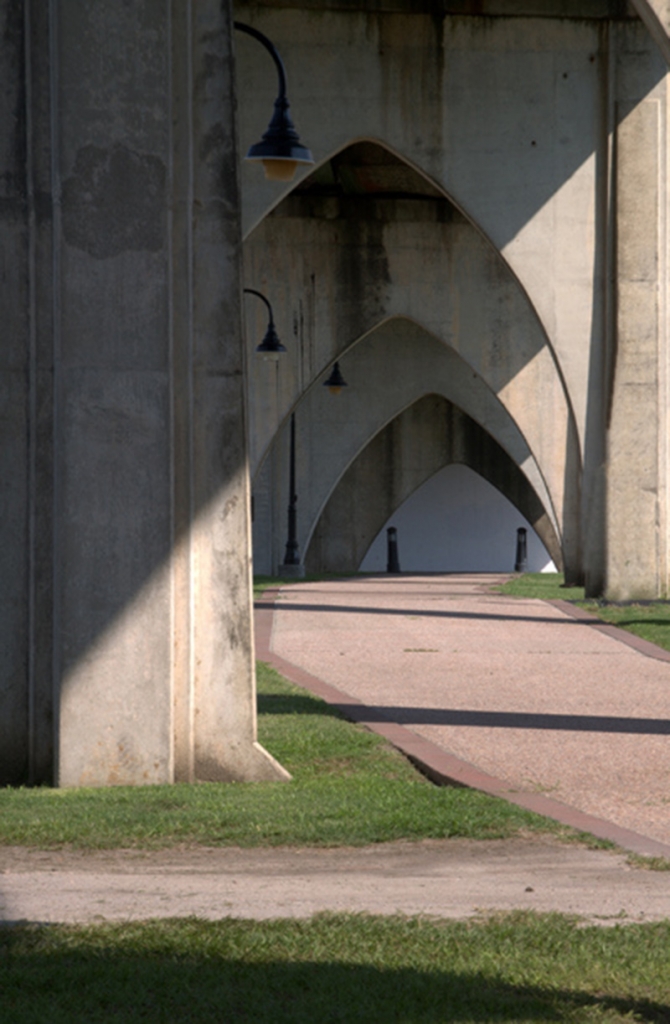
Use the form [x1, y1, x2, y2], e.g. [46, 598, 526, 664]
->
[305, 394, 561, 572]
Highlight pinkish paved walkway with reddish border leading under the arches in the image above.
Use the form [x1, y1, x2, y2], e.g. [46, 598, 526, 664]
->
[256, 574, 670, 856]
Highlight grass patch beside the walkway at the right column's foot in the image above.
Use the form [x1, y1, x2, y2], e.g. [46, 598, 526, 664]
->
[499, 572, 670, 650]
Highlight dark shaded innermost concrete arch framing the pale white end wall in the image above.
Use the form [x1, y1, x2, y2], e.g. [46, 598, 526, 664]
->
[304, 394, 561, 572]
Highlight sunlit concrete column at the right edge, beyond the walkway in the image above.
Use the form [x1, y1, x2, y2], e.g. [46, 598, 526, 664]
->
[604, 30, 668, 600]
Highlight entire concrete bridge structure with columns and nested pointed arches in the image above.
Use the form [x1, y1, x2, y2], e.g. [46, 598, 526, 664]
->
[0, 0, 670, 785]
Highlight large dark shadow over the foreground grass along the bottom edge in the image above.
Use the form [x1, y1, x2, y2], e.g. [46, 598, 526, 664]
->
[0, 927, 670, 1024]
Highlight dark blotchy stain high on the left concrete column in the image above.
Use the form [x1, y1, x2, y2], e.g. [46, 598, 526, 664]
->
[62, 144, 166, 259]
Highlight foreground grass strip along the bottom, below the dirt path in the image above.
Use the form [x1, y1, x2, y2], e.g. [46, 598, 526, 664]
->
[0, 913, 670, 1024]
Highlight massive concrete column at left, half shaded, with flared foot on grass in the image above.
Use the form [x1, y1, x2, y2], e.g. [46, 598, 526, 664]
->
[0, 0, 286, 785]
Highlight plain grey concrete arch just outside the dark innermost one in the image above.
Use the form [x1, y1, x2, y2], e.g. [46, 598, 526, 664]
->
[254, 317, 564, 571]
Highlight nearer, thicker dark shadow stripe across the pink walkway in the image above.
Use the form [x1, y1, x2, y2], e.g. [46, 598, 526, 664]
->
[337, 703, 670, 736]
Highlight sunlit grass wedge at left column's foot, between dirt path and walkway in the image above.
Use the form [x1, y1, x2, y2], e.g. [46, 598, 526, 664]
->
[0, 665, 570, 849]
